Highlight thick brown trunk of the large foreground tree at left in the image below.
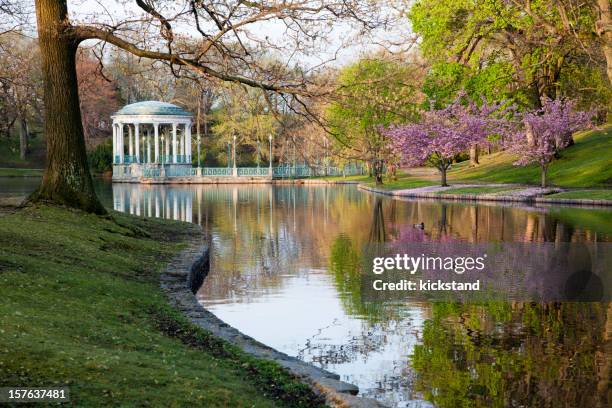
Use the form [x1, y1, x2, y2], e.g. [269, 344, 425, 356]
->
[31, 0, 105, 214]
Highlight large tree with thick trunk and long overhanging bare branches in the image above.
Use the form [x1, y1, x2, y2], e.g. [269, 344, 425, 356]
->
[16, 0, 387, 213]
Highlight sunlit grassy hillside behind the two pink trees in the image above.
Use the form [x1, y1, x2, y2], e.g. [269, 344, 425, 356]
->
[449, 125, 612, 187]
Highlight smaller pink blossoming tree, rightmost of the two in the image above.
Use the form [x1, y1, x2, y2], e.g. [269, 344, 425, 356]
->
[506, 99, 595, 188]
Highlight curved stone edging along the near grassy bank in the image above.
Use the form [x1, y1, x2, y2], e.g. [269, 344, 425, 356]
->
[160, 230, 385, 408]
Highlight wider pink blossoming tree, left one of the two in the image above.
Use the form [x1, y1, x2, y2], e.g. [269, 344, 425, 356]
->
[386, 95, 515, 186]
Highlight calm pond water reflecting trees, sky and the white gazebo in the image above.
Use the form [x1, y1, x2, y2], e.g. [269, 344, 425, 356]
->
[0, 179, 612, 407]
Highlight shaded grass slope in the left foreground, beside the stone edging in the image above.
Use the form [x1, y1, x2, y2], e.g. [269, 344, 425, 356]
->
[0, 206, 326, 407]
